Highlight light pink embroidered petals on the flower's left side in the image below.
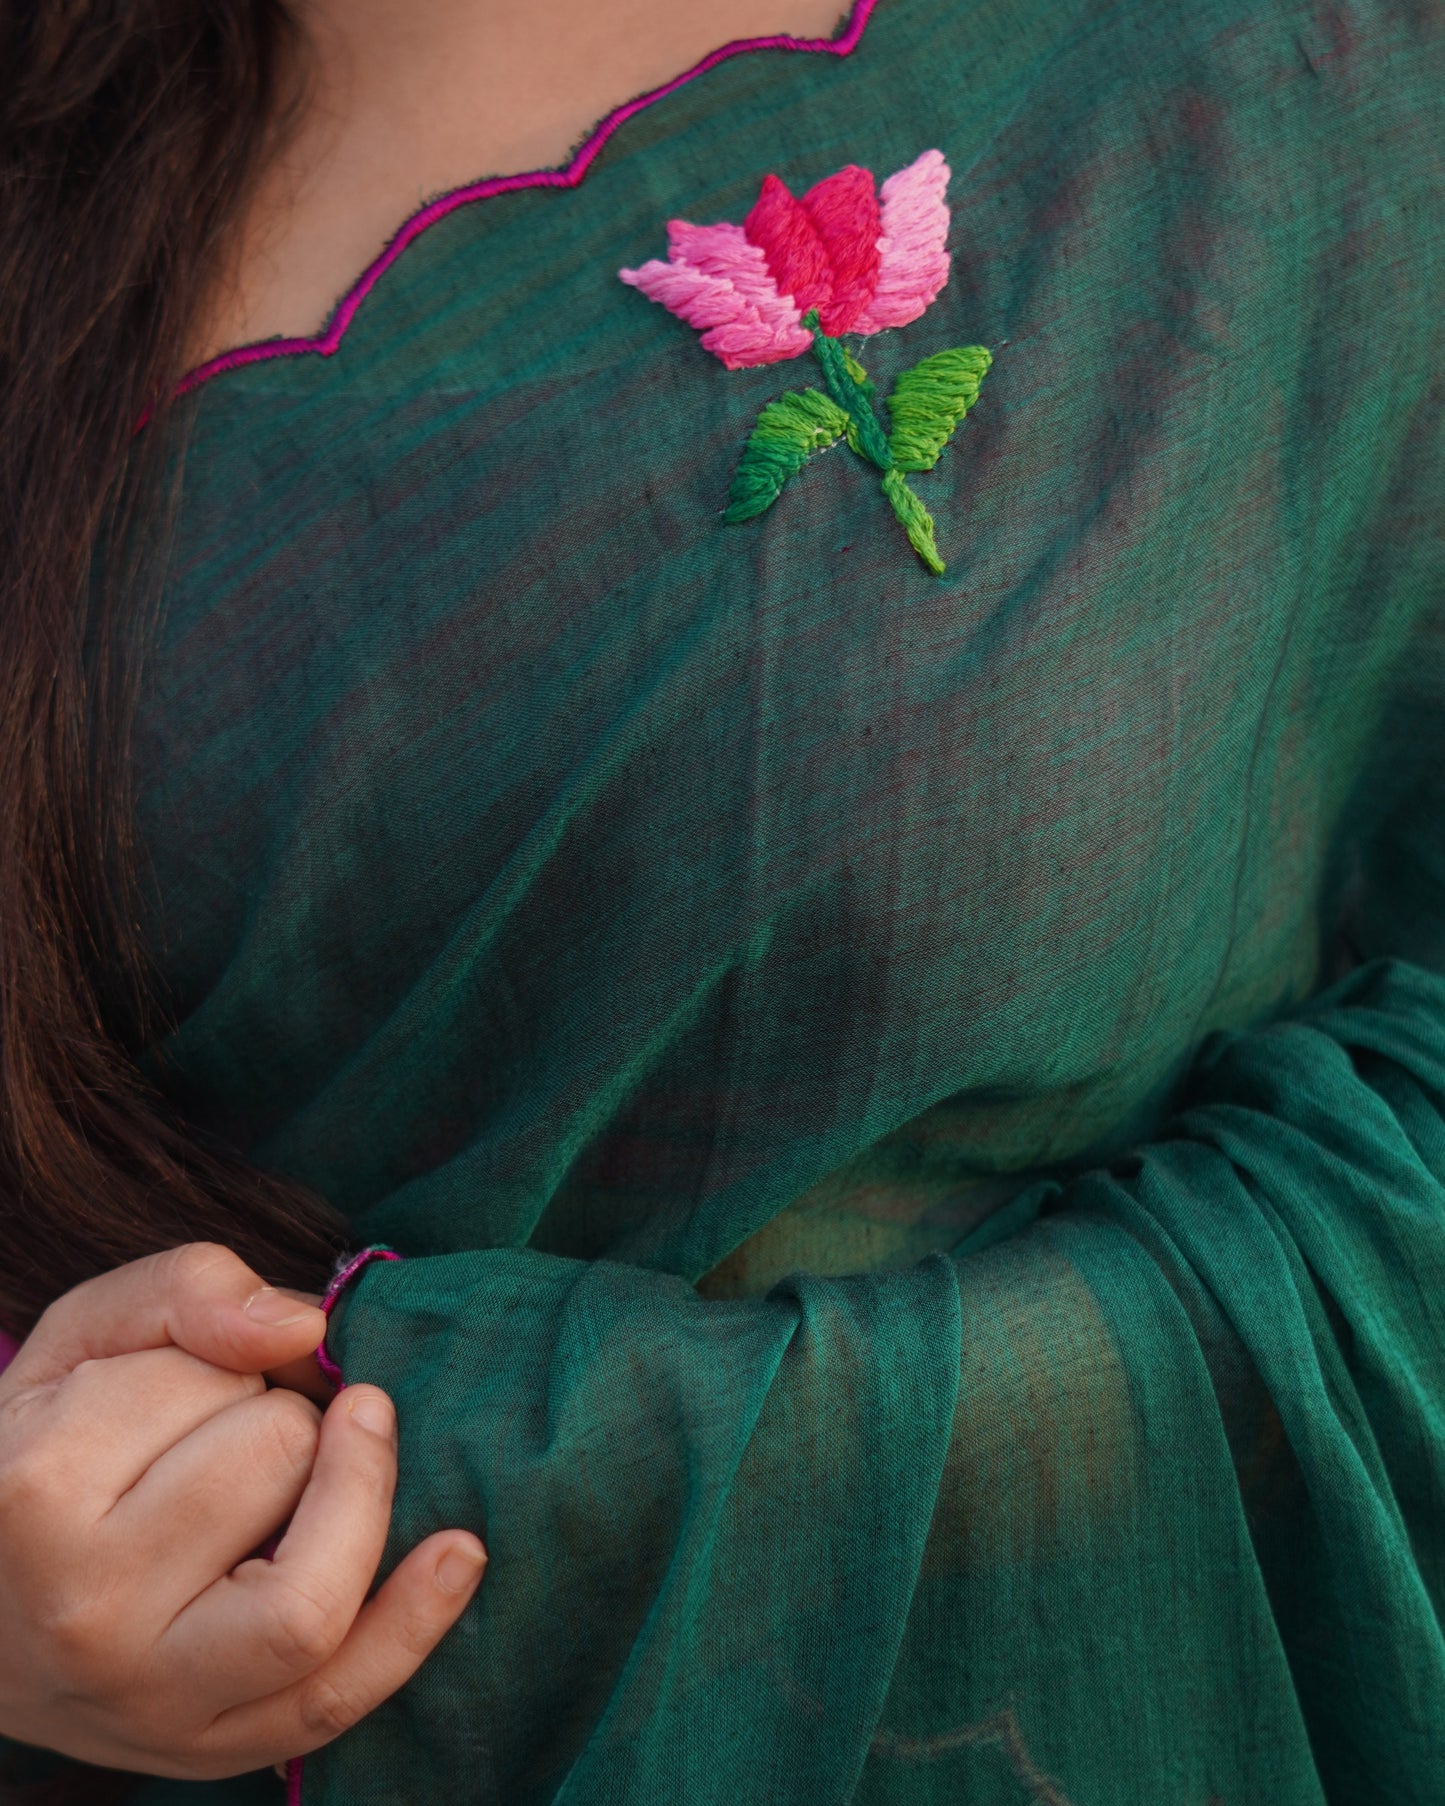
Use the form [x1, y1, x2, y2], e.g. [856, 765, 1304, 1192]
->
[618, 220, 813, 370]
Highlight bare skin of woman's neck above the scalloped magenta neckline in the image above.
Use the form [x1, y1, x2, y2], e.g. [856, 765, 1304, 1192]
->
[186, 0, 847, 367]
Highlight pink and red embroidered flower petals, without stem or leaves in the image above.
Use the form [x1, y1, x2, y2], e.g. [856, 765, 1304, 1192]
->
[618, 150, 948, 370]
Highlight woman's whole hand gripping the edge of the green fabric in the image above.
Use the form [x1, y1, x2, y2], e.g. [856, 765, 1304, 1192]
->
[0, 1243, 486, 1779]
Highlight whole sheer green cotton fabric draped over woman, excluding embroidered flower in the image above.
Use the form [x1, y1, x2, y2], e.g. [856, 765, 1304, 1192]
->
[19, 0, 1445, 1806]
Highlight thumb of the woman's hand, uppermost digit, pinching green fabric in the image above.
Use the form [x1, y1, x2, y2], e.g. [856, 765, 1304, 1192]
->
[5, 1243, 327, 1385]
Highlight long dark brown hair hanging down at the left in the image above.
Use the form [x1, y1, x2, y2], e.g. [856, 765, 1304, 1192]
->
[0, 0, 341, 1333]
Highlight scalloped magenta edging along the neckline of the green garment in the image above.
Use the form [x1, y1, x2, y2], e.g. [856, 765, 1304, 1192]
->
[146, 0, 878, 432]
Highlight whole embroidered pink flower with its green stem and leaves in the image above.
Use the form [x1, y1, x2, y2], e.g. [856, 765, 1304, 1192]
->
[618, 150, 993, 574]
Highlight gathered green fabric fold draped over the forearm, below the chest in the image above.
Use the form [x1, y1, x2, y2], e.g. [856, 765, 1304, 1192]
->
[305, 961, 1445, 1806]
